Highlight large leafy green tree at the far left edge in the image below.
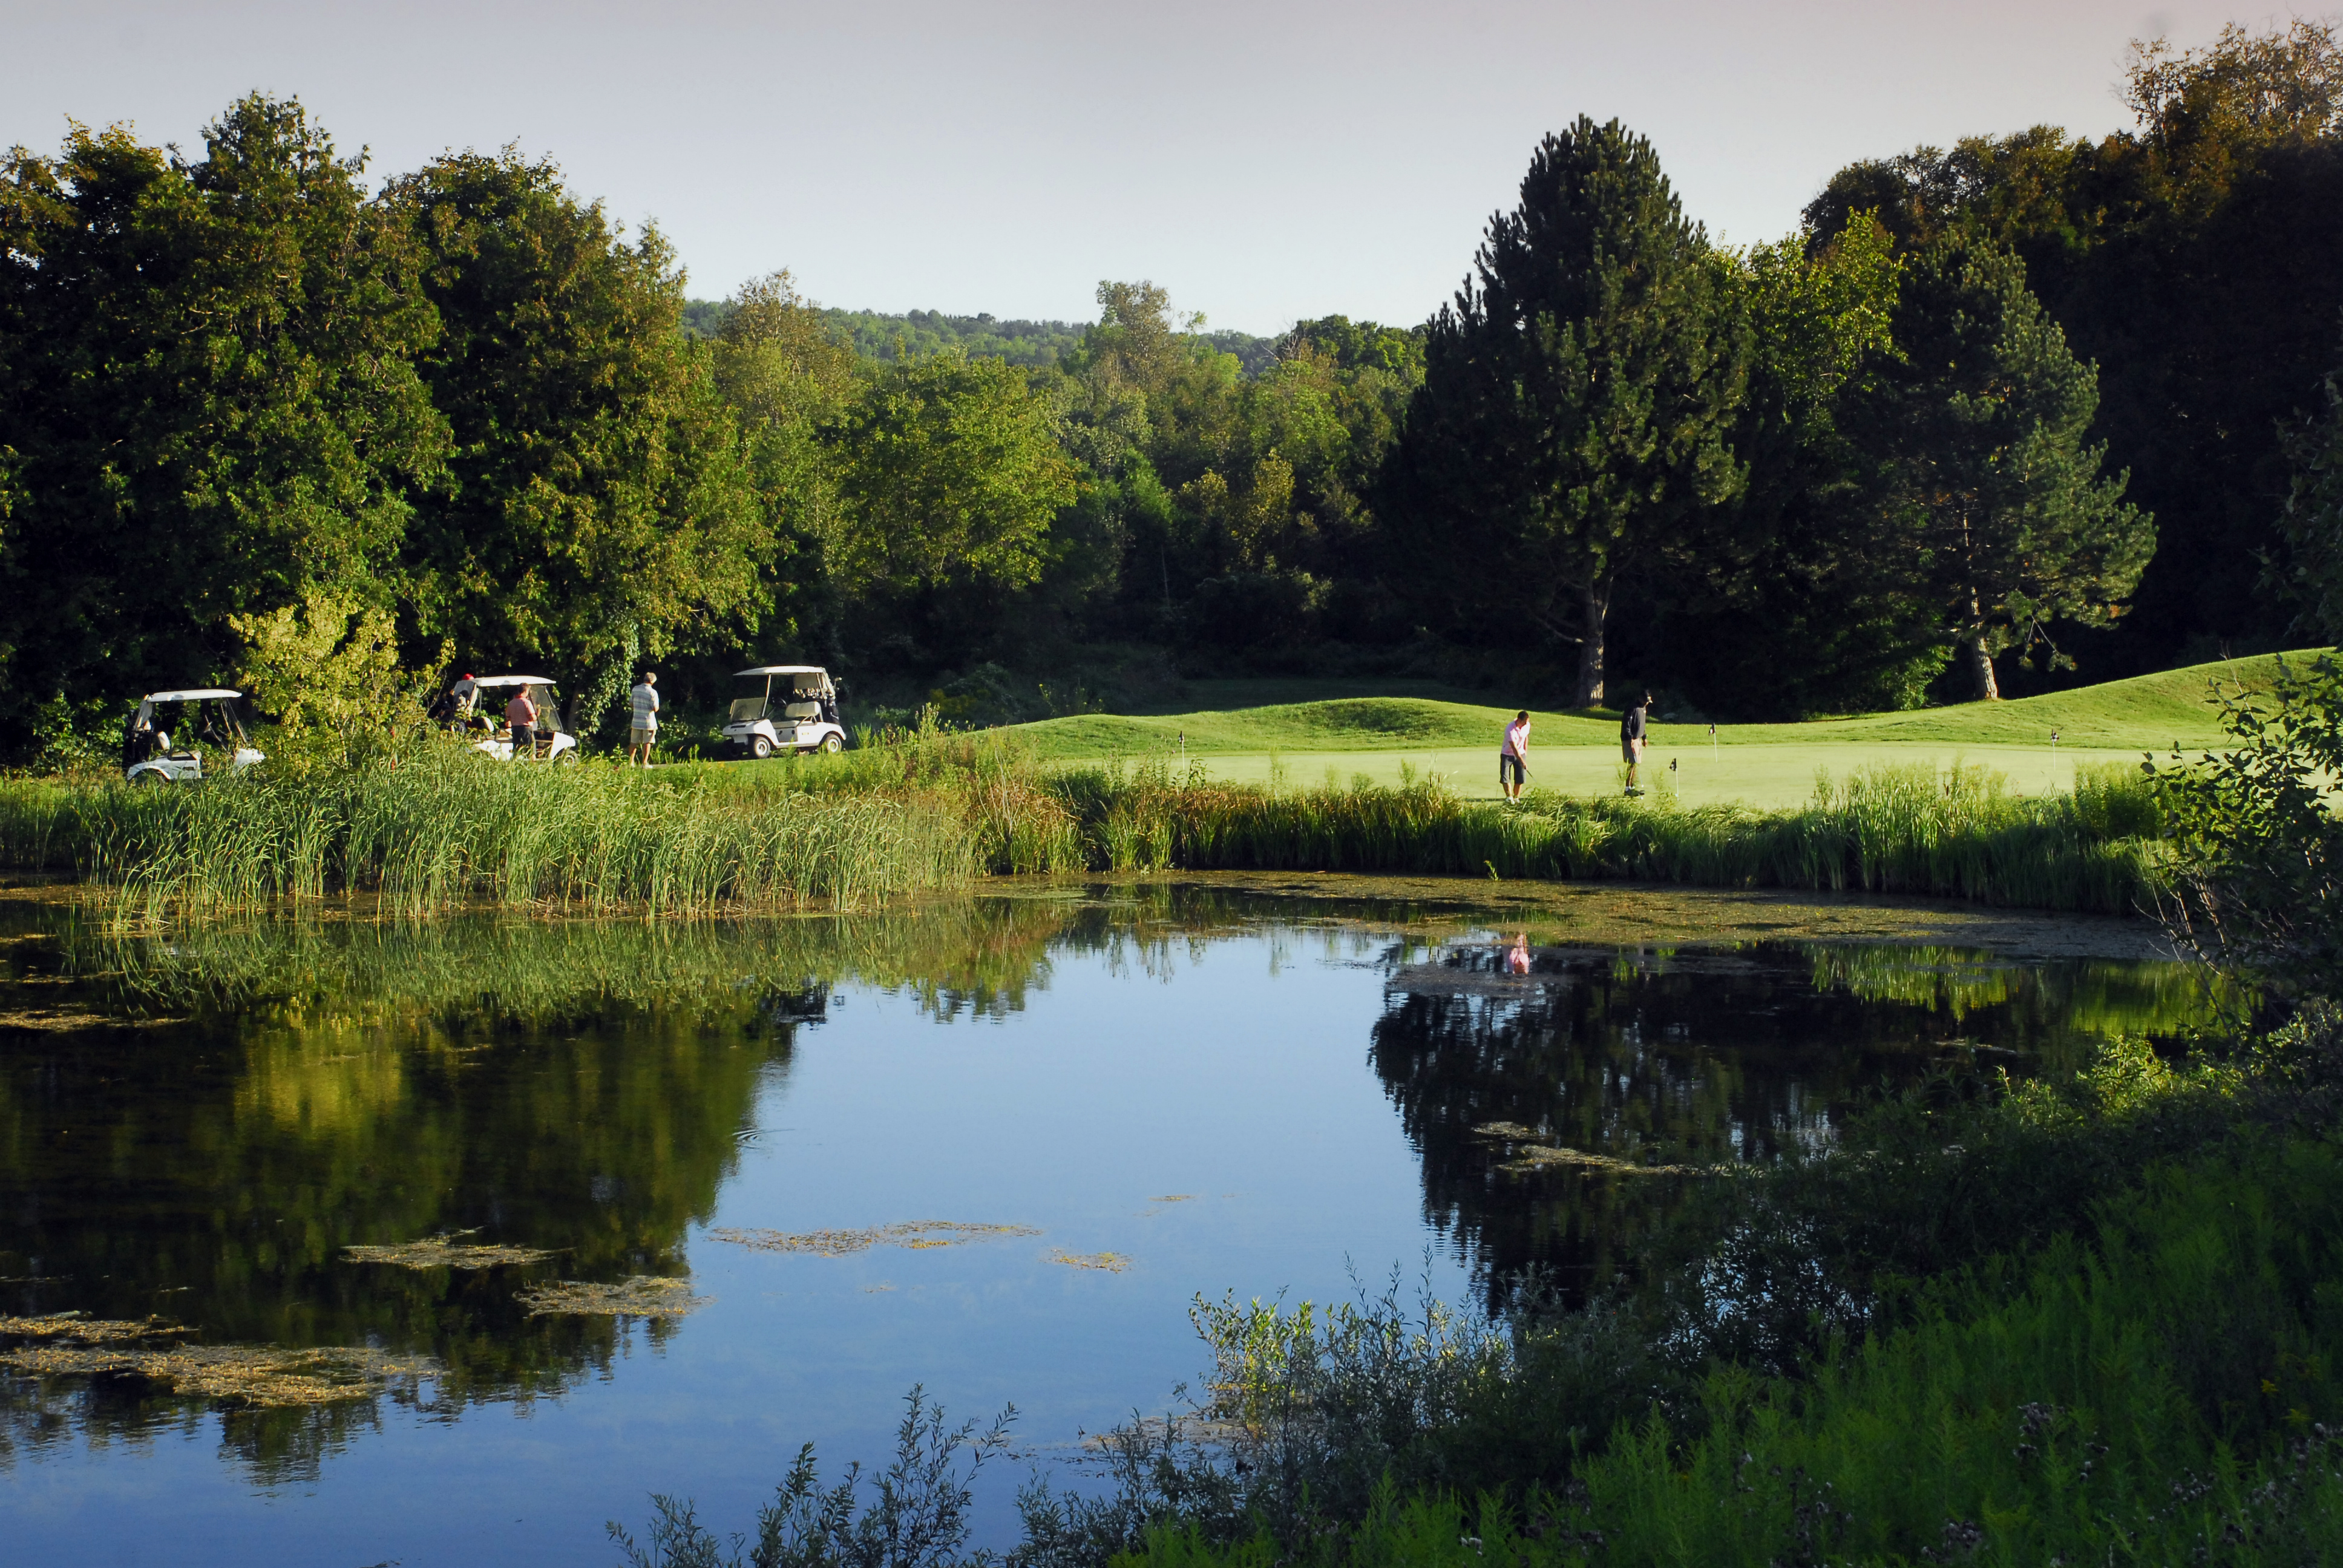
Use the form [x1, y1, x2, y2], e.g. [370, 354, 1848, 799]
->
[0, 94, 448, 722]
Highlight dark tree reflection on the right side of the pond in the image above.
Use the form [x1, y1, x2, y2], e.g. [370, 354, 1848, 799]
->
[1371, 944, 2212, 1296]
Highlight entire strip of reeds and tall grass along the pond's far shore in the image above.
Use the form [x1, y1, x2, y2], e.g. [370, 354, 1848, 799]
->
[0, 736, 2160, 919]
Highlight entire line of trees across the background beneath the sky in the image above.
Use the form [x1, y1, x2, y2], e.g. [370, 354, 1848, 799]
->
[0, 21, 2343, 755]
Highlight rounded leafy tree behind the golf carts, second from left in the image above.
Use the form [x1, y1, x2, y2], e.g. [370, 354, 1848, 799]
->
[387, 152, 773, 727]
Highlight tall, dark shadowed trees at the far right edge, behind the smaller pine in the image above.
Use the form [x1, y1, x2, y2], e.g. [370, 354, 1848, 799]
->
[1806, 19, 2343, 678]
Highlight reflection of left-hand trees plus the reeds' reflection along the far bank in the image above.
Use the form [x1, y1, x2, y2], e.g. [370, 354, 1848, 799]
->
[0, 886, 1443, 1477]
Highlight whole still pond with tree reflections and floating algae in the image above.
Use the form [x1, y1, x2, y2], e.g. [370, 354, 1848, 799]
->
[0, 877, 2205, 1568]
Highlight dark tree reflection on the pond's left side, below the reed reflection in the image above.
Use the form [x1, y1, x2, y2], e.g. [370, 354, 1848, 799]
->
[0, 1008, 790, 1472]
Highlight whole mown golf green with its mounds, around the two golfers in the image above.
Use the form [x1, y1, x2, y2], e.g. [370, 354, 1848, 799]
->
[1005, 654, 2310, 806]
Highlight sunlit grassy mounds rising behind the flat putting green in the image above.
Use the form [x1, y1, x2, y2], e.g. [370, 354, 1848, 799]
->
[1012, 654, 2301, 759]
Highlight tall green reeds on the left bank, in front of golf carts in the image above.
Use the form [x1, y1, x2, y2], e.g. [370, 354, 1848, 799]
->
[0, 740, 1031, 916]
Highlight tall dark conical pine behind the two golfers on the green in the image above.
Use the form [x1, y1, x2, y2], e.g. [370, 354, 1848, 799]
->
[1387, 117, 1748, 708]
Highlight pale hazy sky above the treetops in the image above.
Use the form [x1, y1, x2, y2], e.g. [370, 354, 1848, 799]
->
[0, 0, 2270, 333]
